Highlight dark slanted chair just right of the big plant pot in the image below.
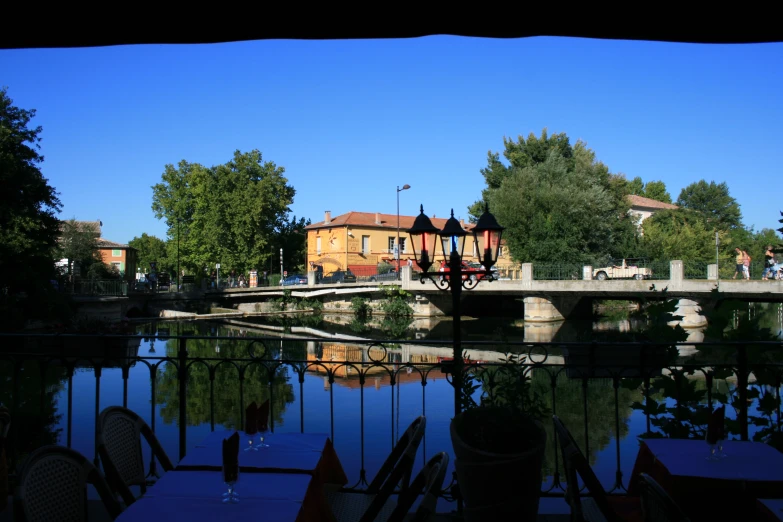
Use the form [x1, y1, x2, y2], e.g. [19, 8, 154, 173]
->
[552, 415, 617, 522]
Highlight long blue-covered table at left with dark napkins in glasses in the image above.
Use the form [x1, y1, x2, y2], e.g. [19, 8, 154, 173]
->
[117, 430, 348, 522]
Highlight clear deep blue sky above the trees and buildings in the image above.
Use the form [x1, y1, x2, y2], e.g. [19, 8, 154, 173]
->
[0, 36, 783, 242]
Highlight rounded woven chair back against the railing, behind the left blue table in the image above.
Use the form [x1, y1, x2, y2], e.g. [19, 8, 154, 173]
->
[97, 406, 174, 506]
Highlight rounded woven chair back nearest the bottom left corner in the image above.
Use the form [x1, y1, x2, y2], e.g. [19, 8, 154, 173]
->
[14, 446, 122, 522]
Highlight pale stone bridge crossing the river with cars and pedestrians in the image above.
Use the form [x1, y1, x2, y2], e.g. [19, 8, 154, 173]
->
[80, 261, 783, 328]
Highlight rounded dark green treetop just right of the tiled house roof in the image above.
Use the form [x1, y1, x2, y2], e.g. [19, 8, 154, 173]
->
[677, 180, 742, 230]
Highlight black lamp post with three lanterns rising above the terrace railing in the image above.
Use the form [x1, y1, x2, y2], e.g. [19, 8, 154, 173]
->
[408, 205, 504, 415]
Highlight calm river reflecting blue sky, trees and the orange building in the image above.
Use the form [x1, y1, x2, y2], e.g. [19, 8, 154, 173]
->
[0, 303, 783, 508]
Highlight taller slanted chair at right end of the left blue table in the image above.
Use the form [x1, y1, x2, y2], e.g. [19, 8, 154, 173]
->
[326, 416, 427, 522]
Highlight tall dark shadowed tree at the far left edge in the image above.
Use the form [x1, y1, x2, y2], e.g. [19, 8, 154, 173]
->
[0, 87, 62, 325]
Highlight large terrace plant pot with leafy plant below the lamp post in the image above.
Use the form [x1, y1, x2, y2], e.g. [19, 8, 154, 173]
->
[450, 355, 548, 522]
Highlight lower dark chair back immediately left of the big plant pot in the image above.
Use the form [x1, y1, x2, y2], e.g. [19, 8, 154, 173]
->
[387, 452, 449, 522]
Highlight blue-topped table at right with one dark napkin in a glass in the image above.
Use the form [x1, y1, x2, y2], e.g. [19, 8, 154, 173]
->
[628, 439, 783, 520]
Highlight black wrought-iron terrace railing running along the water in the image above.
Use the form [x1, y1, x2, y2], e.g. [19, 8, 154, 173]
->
[0, 330, 783, 499]
